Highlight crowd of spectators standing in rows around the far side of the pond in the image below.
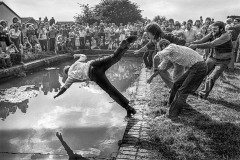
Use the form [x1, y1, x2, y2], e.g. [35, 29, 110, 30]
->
[0, 17, 240, 68]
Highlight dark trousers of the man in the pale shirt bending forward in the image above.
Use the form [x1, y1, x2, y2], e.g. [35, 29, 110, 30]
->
[168, 62, 207, 117]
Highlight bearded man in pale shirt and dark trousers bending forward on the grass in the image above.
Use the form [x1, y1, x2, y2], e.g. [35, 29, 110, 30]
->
[147, 39, 207, 118]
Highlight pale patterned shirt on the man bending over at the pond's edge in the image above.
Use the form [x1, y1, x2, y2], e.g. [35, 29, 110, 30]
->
[157, 43, 204, 68]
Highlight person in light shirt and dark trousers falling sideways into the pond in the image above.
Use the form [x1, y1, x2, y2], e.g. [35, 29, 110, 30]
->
[54, 36, 137, 117]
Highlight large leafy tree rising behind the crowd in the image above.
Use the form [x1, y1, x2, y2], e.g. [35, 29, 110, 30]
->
[74, 0, 143, 24]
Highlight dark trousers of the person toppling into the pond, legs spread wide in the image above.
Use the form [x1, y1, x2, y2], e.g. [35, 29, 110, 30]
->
[89, 44, 129, 109]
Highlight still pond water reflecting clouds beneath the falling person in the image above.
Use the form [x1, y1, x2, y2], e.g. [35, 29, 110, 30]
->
[0, 58, 141, 160]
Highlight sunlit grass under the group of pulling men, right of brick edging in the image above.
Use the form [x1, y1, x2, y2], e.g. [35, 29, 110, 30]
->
[147, 64, 240, 160]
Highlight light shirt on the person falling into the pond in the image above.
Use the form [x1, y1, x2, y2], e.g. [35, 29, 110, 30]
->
[63, 60, 92, 89]
